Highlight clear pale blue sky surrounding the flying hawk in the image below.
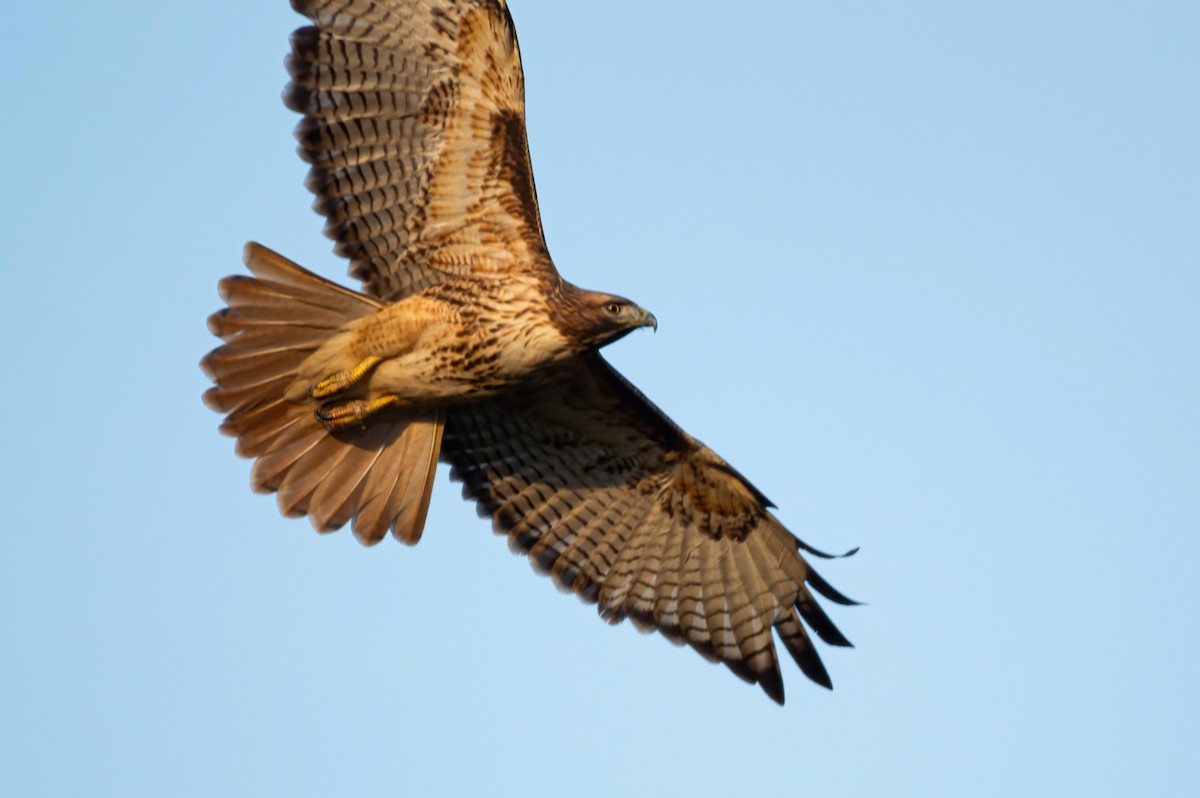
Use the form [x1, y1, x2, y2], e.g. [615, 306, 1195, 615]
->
[0, 0, 1200, 798]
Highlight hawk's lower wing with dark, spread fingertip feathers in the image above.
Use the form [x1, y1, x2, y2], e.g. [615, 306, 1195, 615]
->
[442, 353, 853, 703]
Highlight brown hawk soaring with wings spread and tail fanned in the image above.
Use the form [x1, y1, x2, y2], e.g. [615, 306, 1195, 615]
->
[200, 0, 857, 704]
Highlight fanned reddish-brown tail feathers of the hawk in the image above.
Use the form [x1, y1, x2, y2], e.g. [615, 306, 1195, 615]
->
[200, 244, 444, 545]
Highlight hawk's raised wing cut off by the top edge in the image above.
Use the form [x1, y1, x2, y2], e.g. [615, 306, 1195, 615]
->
[284, 0, 554, 301]
